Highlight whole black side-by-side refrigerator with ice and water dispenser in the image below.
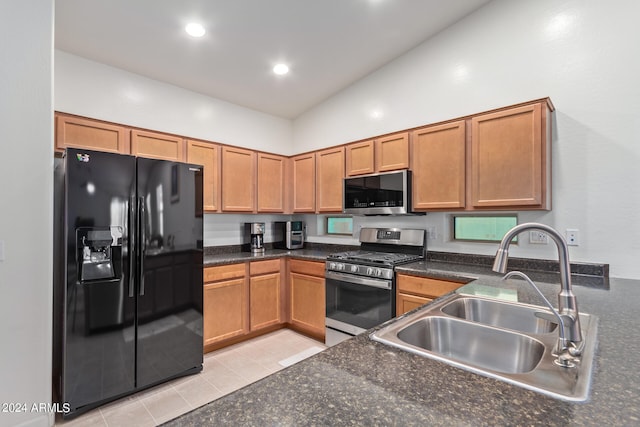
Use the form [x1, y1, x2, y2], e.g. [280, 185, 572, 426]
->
[53, 149, 203, 418]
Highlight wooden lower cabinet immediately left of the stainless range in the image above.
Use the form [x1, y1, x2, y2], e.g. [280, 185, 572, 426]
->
[289, 259, 326, 342]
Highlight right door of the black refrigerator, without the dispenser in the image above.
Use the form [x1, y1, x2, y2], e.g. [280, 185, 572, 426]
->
[137, 158, 203, 388]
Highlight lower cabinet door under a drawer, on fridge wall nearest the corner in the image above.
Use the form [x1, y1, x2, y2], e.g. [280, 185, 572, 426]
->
[249, 272, 281, 331]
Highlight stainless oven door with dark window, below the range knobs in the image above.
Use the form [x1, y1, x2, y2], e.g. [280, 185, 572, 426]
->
[325, 271, 395, 345]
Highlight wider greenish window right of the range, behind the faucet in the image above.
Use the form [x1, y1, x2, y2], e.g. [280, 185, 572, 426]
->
[451, 214, 518, 243]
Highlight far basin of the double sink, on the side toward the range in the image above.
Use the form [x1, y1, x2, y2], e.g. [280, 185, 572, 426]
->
[442, 297, 558, 334]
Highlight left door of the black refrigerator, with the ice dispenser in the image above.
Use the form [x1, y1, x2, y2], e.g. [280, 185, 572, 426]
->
[54, 149, 135, 411]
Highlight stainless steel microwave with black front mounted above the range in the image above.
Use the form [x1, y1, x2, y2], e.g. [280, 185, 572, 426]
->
[342, 170, 412, 215]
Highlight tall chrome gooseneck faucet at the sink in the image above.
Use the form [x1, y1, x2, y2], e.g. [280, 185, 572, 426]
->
[493, 226, 584, 356]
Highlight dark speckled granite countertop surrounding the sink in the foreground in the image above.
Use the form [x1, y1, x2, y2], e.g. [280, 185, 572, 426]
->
[168, 262, 640, 426]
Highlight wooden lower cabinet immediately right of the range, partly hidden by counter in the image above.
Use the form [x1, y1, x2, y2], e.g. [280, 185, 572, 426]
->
[396, 274, 465, 316]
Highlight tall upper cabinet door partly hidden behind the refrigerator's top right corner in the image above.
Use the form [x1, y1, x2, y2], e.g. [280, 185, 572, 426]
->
[187, 140, 220, 212]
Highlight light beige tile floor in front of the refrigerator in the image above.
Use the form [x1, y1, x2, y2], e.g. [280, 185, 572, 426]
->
[56, 329, 325, 427]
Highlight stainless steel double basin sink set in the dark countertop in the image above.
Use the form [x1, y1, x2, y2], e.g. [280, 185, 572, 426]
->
[371, 294, 597, 401]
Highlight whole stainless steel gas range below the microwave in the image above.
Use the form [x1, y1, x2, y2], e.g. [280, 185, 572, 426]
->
[325, 228, 426, 346]
